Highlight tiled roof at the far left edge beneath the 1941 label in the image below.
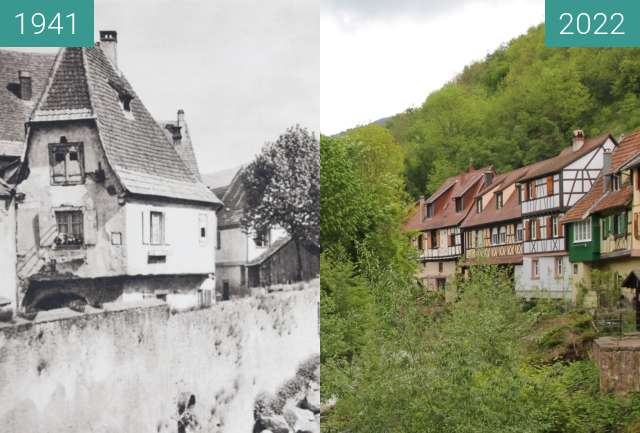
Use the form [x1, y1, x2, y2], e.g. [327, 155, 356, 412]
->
[0, 50, 55, 143]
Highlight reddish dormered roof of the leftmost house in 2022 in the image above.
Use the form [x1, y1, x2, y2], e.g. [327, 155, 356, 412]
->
[404, 167, 493, 230]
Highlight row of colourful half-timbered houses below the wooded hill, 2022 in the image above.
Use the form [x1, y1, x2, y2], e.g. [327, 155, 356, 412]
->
[405, 130, 640, 301]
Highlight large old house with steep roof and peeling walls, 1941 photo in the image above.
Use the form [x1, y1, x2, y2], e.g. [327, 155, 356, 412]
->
[10, 31, 221, 309]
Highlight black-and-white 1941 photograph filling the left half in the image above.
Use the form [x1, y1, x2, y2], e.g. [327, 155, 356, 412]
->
[0, 0, 320, 433]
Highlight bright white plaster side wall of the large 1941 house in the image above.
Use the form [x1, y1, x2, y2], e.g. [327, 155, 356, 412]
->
[124, 201, 217, 275]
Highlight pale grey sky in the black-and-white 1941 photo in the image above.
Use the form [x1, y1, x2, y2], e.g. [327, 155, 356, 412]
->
[18, 0, 320, 173]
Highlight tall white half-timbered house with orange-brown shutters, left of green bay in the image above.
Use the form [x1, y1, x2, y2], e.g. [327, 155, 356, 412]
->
[515, 131, 617, 299]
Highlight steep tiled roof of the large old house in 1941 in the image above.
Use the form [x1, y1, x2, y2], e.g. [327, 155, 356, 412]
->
[27, 46, 221, 205]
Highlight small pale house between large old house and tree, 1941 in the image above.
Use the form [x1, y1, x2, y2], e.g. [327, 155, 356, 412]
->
[210, 168, 289, 299]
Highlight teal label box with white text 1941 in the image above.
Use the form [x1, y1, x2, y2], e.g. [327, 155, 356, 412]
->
[0, 0, 94, 47]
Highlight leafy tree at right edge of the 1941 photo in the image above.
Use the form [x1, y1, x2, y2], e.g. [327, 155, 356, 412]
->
[242, 125, 320, 279]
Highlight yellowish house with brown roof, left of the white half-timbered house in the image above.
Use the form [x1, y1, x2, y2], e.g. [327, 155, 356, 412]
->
[461, 166, 531, 269]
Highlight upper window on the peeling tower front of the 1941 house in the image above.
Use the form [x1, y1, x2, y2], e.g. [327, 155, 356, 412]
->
[49, 143, 84, 185]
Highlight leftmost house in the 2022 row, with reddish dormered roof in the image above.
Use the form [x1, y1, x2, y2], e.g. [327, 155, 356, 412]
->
[404, 167, 495, 290]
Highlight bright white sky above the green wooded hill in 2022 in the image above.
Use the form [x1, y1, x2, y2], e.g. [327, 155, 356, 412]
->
[320, 0, 544, 134]
